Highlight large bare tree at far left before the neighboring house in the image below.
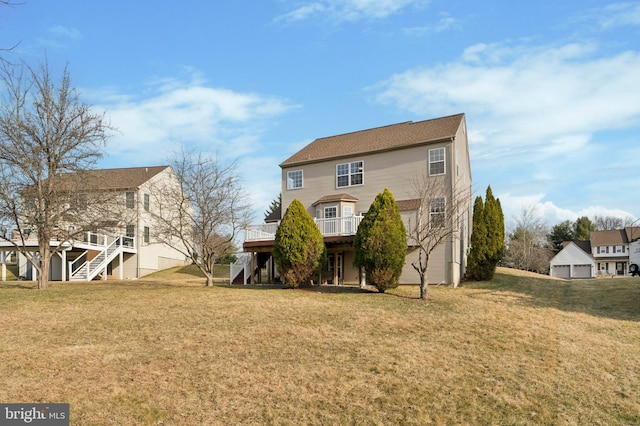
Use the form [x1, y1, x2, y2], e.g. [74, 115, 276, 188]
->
[0, 61, 112, 289]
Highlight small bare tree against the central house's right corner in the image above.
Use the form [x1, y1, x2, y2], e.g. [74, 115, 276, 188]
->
[407, 174, 471, 299]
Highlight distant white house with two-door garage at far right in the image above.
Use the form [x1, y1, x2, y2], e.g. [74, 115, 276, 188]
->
[549, 227, 640, 279]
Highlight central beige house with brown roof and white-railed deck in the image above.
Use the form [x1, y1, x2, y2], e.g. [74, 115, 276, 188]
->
[239, 114, 472, 286]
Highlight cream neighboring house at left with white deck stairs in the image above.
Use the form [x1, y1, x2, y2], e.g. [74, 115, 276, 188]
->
[0, 166, 186, 281]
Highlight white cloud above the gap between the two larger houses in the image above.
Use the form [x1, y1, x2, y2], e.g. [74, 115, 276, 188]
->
[93, 75, 294, 163]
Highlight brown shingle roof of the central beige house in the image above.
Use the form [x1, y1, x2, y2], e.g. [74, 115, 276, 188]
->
[280, 114, 464, 167]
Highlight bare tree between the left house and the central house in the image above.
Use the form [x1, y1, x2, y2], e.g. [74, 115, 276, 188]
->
[154, 150, 251, 286]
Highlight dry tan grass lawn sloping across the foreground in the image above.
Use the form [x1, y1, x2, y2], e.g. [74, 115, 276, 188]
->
[0, 273, 640, 425]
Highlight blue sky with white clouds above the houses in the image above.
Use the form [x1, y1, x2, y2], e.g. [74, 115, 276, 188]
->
[0, 0, 640, 225]
